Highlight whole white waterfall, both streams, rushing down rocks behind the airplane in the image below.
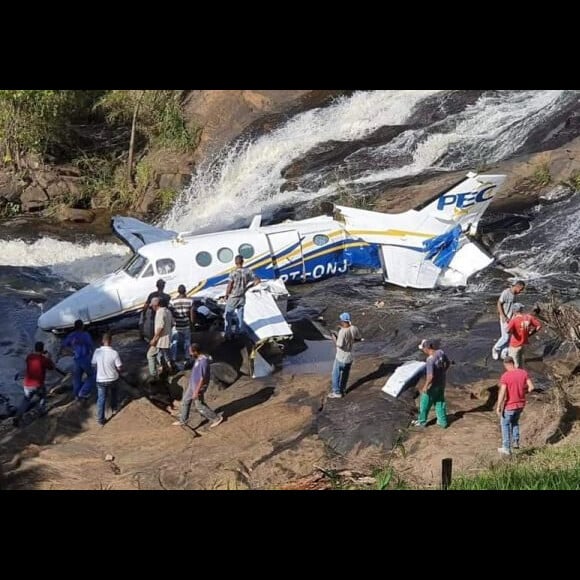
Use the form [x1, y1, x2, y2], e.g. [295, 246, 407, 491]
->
[163, 91, 572, 231]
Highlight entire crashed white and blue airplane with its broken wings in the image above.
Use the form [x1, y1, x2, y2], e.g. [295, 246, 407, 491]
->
[38, 173, 505, 342]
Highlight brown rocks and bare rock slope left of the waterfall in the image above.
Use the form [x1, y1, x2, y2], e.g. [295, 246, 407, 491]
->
[0, 91, 346, 223]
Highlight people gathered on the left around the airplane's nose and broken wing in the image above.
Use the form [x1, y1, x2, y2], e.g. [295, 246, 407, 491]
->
[14, 256, 260, 427]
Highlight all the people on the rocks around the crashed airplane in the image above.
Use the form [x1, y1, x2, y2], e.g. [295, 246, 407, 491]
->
[15, 245, 542, 455]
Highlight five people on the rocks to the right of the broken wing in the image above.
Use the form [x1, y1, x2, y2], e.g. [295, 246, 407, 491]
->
[327, 280, 542, 455]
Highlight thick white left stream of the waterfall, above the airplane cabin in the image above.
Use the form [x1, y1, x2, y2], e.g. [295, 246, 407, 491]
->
[163, 91, 441, 231]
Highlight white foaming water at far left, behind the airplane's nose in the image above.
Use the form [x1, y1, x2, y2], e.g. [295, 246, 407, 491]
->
[0, 237, 130, 283]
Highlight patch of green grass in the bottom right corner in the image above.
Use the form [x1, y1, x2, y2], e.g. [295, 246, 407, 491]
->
[449, 445, 580, 490]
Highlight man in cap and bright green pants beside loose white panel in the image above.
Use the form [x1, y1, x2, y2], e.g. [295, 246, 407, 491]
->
[412, 339, 450, 429]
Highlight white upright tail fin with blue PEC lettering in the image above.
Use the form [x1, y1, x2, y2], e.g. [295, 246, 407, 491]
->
[415, 172, 506, 235]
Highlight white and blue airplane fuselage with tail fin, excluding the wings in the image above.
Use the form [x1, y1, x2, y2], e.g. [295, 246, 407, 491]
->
[38, 174, 504, 330]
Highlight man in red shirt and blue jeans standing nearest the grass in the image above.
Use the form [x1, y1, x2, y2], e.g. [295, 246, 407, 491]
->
[496, 355, 534, 455]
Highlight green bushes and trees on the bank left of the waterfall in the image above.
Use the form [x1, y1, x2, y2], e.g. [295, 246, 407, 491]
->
[0, 90, 200, 217]
